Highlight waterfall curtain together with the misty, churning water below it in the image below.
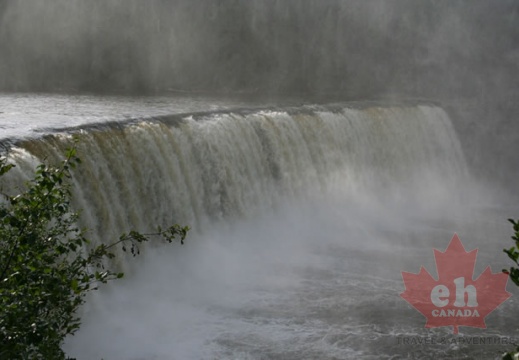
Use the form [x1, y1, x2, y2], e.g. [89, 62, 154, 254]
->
[2, 97, 514, 359]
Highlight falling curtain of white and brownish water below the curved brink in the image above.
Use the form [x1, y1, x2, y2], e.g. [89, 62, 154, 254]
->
[4, 104, 466, 246]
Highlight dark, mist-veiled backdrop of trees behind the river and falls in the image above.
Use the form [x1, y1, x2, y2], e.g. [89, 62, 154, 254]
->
[0, 0, 519, 98]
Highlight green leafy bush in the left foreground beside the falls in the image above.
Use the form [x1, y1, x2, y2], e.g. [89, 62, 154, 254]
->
[0, 148, 189, 359]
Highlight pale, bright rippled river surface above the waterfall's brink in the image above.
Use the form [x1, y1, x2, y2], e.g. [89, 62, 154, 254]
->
[0, 93, 276, 140]
